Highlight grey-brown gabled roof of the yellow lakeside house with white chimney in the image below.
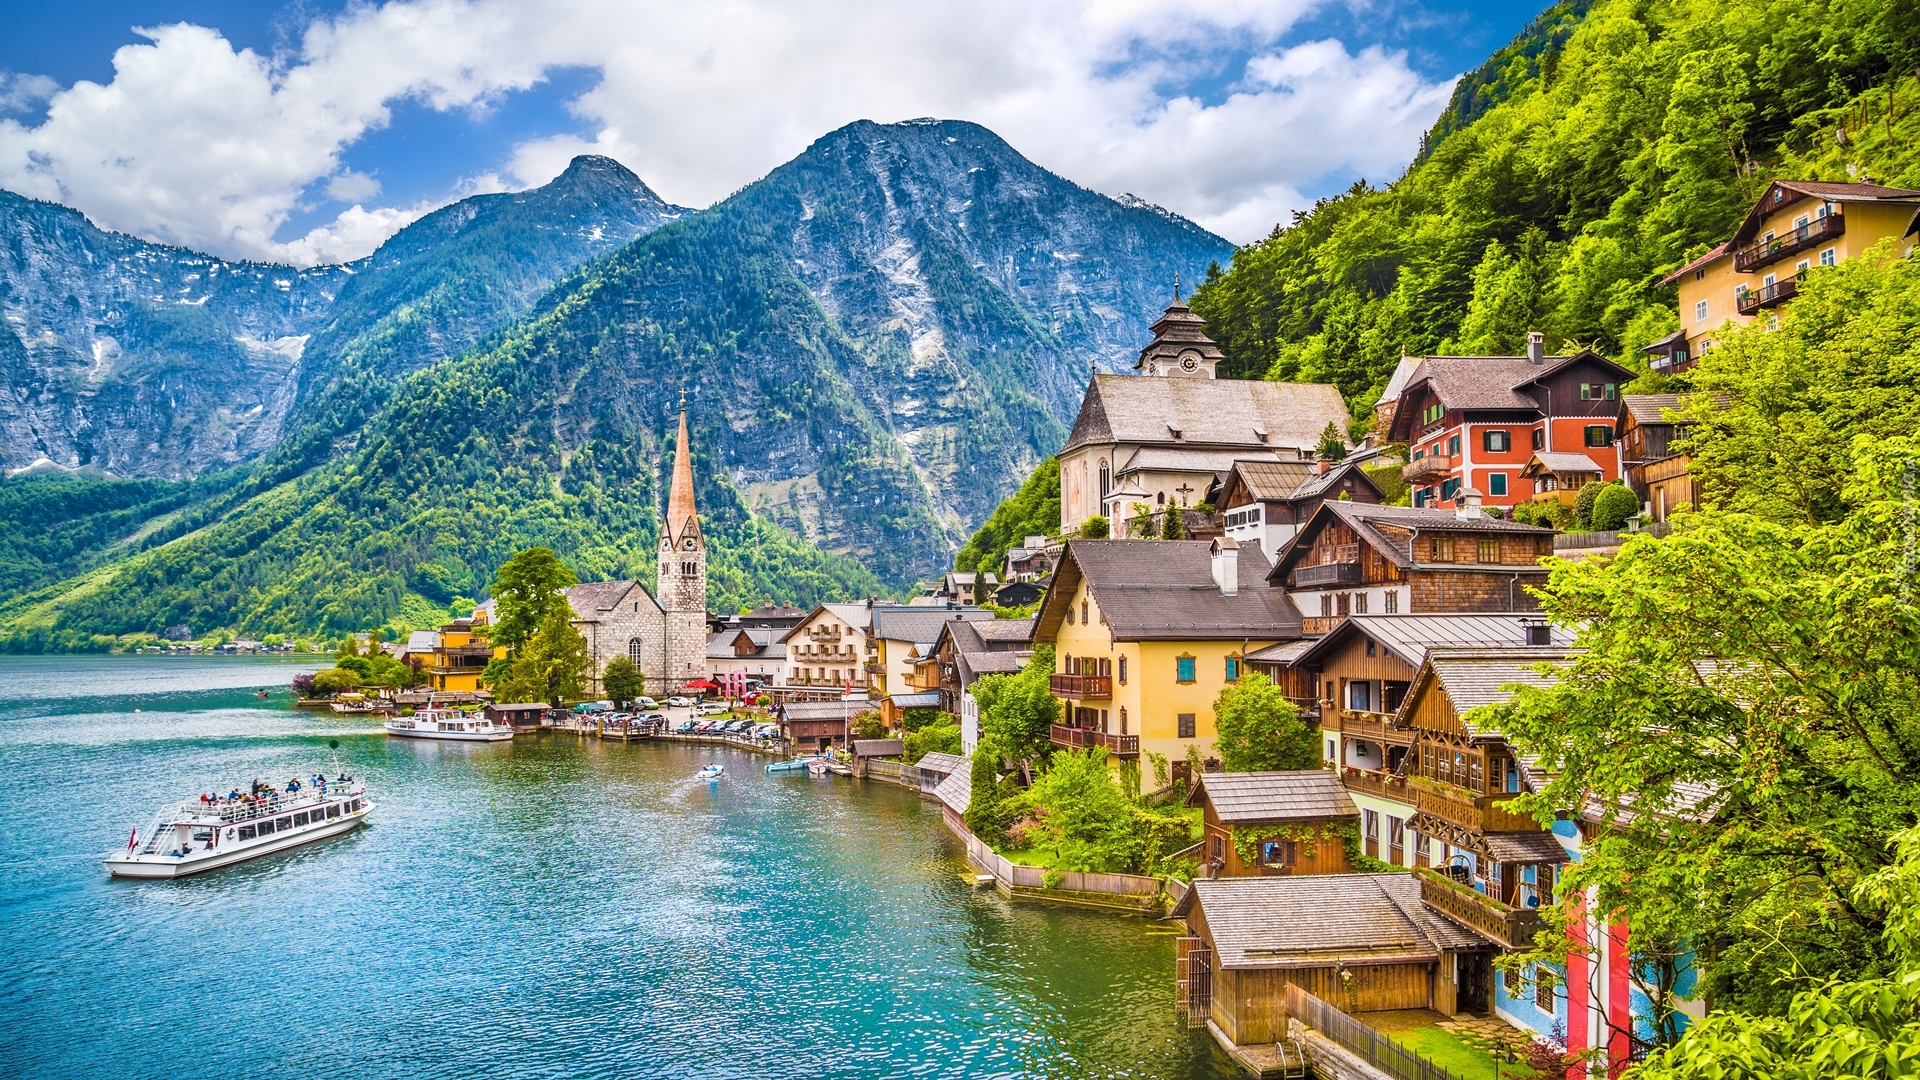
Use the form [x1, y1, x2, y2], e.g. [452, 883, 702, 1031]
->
[1033, 540, 1300, 642]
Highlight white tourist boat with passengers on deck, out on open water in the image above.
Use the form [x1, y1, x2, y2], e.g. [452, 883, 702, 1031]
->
[106, 776, 372, 878]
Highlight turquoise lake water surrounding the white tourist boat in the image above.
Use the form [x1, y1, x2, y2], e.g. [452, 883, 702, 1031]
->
[0, 657, 1235, 1080]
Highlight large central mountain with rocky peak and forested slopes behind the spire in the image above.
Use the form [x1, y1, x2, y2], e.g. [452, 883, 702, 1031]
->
[0, 121, 1233, 648]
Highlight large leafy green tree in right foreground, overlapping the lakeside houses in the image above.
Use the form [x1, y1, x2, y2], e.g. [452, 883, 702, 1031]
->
[1476, 436, 1920, 1014]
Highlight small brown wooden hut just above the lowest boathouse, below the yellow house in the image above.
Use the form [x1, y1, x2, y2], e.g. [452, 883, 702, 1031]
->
[1187, 769, 1359, 878]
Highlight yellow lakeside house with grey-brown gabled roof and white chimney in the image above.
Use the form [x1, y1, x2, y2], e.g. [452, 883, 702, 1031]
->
[1033, 538, 1300, 761]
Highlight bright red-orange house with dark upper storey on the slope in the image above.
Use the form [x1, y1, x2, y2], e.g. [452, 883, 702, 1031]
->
[1386, 332, 1634, 507]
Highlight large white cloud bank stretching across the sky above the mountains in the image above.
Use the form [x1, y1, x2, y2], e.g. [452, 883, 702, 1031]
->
[0, 0, 1450, 263]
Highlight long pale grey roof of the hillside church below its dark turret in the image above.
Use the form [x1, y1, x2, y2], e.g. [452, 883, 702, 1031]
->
[1062, 375, 1348, 454]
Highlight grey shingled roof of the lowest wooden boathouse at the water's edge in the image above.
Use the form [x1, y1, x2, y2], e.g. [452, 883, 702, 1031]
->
[1192, 874, 1486, 970]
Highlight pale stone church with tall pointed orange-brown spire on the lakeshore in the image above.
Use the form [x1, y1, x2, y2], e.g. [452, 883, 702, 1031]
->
[566, 409, 707, 698]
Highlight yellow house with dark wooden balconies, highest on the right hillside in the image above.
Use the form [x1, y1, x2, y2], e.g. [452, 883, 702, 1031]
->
[1647, 181, 1920, 371]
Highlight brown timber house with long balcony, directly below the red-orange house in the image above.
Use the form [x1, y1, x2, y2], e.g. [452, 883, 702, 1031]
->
[1267, 496, 1553, 636]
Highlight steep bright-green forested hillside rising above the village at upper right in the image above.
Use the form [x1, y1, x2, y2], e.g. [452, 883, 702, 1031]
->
[1192, 0, 1920, 417]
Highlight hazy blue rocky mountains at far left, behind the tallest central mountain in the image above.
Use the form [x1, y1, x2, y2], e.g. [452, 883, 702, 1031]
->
[0, 158, 685, 477]
